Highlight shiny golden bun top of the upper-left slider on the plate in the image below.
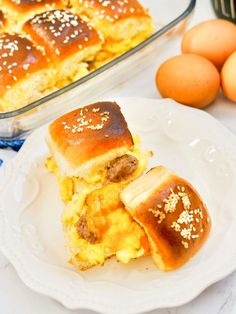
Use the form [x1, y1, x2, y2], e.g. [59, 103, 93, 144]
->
[49, 102, 133, 166]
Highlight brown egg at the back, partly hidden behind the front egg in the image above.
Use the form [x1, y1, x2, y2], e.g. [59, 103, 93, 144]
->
[182, 19, 236, 69]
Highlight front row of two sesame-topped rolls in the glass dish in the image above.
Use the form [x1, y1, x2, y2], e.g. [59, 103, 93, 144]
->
[0, 10, 102, 111]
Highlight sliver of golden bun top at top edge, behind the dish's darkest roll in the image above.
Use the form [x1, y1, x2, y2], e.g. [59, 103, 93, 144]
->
[3, 0, 61, 13]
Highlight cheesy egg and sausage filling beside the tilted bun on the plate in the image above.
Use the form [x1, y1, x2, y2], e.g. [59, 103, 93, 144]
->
[62, 183, 149, 270]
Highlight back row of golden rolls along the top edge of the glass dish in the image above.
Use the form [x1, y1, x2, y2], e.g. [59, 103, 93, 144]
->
[0, 0, 154, 67]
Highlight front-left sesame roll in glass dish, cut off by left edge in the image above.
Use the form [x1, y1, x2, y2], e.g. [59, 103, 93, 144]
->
[0, 33, 53, 111]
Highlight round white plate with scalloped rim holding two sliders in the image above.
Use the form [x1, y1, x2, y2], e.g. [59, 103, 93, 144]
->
[0, 98, 236, 313]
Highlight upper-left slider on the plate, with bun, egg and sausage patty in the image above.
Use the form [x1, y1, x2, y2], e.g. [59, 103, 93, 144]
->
[46, 102, 150, 202]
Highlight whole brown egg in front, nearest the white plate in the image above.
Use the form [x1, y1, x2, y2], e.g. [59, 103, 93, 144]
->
[156, 54, 220, 108]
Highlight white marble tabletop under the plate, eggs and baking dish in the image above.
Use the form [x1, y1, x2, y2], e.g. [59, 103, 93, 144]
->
[0, 0, 236, 314]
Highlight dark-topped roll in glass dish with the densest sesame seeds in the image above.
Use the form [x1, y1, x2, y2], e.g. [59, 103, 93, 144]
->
[23, 10, 102, 87]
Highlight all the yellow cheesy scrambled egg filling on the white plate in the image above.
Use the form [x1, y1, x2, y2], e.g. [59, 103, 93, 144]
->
[45, 137, 150, 270]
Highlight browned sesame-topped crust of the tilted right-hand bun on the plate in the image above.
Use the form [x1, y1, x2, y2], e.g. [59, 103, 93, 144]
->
[126, 169, 211, 270]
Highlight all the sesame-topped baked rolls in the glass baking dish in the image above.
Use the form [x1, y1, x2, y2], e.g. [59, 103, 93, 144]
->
[0, 0, 152, 111]
